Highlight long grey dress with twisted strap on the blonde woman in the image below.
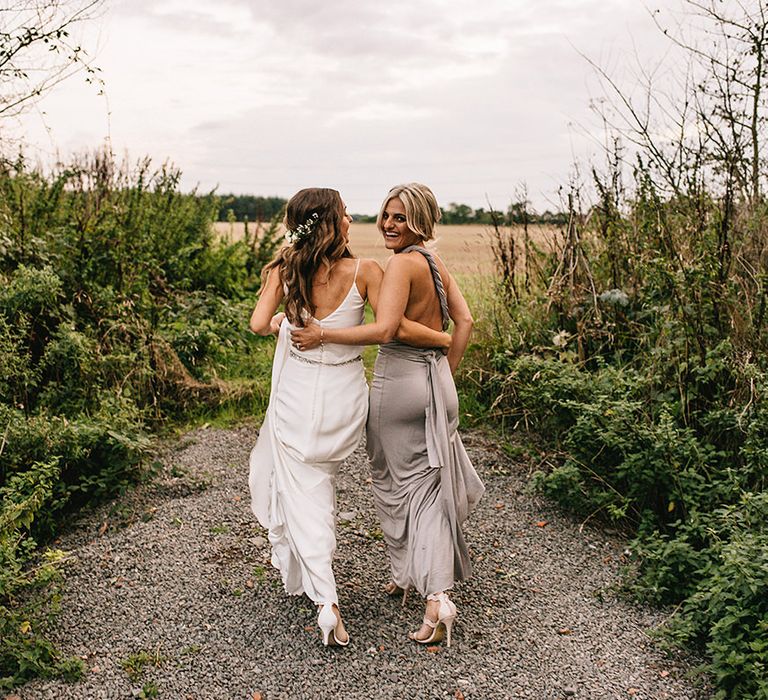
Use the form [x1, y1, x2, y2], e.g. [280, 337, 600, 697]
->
[367, 246, 485, 596]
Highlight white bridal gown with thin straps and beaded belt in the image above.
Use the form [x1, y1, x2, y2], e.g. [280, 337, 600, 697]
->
[249, 261, 368, 603]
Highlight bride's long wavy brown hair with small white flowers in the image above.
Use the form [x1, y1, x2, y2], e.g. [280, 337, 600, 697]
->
[262, 187, 352, 326]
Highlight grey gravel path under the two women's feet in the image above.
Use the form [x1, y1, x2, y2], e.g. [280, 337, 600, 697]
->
[13, 427, 710, 700]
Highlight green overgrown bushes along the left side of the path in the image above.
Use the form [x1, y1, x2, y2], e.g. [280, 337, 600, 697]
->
[0, 153, 279, 697]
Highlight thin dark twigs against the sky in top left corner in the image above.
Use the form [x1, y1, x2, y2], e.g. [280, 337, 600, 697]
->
[0, 0, 104, 117]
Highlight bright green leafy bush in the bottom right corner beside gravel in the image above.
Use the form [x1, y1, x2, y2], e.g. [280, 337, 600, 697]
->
[636, 492, 768, 700]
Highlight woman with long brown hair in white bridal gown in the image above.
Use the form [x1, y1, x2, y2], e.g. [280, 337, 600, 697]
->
[249, 188, 450, 646]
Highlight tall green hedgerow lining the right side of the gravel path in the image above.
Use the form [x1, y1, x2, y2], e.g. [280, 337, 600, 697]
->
[461, 130, 768, 699]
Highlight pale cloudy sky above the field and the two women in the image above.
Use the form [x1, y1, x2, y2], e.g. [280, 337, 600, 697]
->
[7, 0, 679, 214]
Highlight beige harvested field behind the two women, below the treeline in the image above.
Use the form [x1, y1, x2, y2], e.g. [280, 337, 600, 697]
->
[215, 221, 559, 275]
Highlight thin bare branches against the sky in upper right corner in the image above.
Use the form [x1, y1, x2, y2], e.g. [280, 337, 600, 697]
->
[587, 0, 768, 203]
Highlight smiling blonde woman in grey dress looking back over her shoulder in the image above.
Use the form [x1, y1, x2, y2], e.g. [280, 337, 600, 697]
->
[292, 183, 484, 646]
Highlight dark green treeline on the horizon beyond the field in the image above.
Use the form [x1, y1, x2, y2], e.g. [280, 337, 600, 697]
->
[218, 194, 568, 226]
